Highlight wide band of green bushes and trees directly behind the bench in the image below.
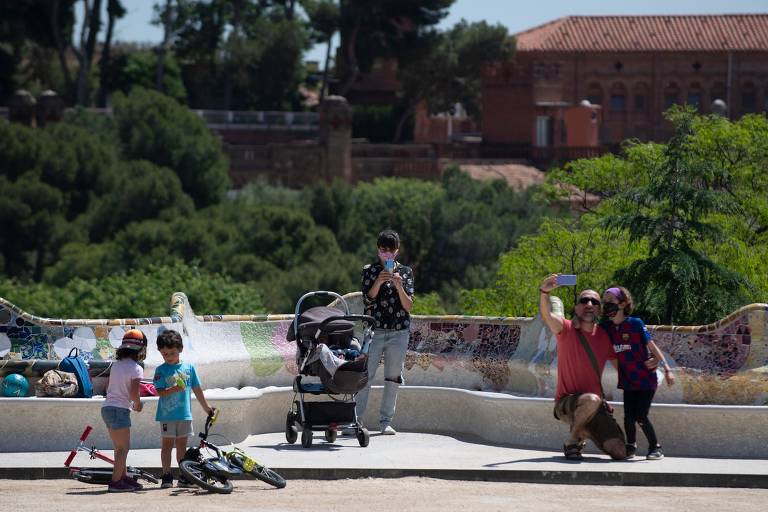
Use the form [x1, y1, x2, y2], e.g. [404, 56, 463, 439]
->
[0, 89, 768, 324]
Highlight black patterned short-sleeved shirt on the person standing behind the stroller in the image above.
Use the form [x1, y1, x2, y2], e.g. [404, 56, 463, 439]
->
[362, 261, 413, 331]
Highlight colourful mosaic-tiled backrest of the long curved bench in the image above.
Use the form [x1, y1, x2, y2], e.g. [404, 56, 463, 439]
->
[0, 293, 768, 405]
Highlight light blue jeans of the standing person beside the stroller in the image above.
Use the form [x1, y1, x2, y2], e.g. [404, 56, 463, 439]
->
[355, 328, 410, 427]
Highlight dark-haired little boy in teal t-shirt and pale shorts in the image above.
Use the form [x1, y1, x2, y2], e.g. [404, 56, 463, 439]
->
[153, 330, 213, 489]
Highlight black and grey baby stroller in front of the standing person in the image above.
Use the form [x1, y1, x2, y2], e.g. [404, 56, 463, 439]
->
[285, 291, 374, 448]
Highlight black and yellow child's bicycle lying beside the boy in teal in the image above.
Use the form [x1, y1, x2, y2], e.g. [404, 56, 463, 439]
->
[179, 409, 285, 494]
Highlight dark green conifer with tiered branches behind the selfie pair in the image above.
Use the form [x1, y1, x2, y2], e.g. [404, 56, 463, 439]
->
[605, 109, 748, 324]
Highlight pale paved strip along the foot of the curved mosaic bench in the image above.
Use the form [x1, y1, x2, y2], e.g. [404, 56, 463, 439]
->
[0, 432, 768, 489]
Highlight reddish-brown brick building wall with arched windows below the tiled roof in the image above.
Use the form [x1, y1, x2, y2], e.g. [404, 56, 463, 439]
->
[483, 51, 768, 145]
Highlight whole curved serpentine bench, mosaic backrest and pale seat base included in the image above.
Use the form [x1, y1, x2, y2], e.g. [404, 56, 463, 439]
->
[0, 293, 768, 457]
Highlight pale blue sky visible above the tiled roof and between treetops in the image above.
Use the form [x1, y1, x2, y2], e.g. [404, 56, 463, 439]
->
[76, 0, 768, 63]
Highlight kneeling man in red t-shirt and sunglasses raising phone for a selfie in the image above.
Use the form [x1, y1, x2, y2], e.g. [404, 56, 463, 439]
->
[539, 274, 626, 460]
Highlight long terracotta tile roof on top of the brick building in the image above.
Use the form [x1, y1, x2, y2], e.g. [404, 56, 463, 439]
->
[516, 14, 768, 52]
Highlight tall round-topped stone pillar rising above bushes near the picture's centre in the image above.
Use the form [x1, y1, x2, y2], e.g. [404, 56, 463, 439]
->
[319, 96, 353, 183]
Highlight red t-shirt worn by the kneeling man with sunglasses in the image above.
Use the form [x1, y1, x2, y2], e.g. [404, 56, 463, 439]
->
[555, 320, 616, 400]
